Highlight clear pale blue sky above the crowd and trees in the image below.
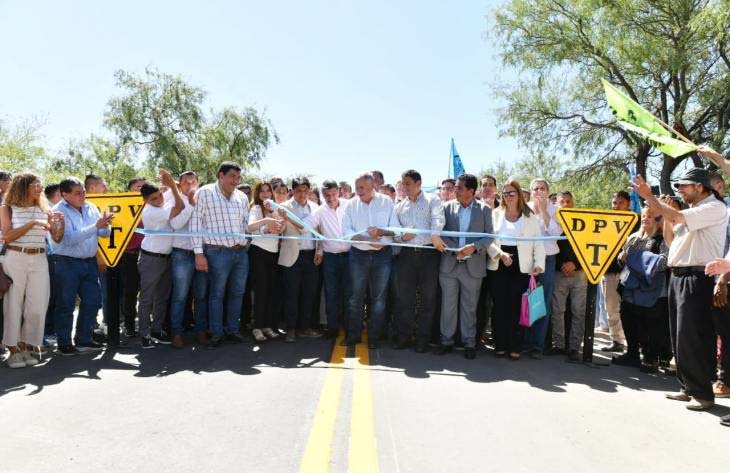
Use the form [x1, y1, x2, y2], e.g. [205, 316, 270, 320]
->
[0, 0, 519, 185]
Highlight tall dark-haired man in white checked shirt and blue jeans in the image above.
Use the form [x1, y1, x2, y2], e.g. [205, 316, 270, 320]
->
[190, 161, 248, 349]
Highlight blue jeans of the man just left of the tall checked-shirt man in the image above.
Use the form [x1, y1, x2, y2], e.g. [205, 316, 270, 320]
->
[170, 248, 208, 336]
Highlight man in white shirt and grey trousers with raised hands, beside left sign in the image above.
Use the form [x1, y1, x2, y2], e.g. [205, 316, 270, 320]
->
[137, 169, 184, 349]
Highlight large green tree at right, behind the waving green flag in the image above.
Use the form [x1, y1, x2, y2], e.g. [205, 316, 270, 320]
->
[494, 0, 730, 193]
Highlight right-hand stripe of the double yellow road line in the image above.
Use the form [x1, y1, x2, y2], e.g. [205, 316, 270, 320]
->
[347, 332, 378, 473]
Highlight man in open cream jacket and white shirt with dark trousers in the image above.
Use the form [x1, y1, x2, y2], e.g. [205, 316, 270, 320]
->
[272, 176, 322, 343]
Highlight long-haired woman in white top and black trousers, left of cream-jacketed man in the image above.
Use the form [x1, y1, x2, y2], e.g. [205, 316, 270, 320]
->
[248, 181, 283, 342]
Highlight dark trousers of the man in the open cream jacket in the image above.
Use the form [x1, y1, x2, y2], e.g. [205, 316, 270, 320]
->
[284, 250, 319, 330]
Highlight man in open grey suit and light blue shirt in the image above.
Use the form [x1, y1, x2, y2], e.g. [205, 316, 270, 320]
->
[434, 174, 493, 360]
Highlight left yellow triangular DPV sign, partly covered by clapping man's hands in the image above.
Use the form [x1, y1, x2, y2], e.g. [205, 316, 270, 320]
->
[86, 192, 144, 268]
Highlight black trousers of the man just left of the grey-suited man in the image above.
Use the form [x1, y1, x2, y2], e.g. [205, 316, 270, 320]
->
[395, 247, 441, 344]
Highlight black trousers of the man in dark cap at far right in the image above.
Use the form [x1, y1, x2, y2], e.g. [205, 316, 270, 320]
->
[669, 272, 717, 401]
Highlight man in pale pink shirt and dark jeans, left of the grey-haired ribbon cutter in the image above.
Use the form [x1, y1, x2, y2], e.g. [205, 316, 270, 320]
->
[309, 180, 352, 338]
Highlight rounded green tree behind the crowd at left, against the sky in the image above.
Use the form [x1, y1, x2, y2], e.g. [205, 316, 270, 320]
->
[104, 68, 278, 180]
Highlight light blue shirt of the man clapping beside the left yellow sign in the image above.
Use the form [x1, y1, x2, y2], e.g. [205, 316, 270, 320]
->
[52, 199, 111, 258]
